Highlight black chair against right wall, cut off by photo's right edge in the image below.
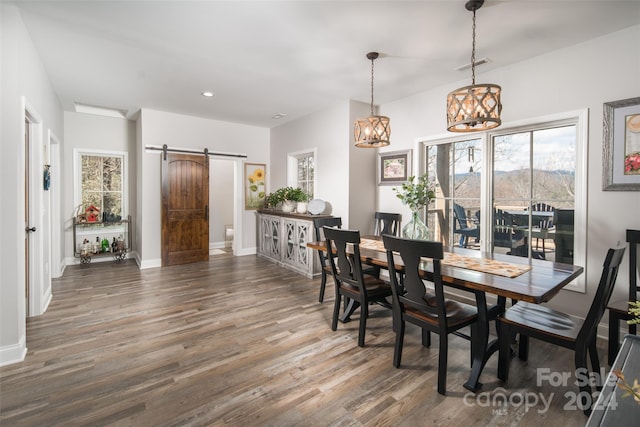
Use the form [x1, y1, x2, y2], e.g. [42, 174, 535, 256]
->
[607, 230, 640, 365]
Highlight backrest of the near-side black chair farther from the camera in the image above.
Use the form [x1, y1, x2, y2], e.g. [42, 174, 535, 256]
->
[324, 226, 367, 296]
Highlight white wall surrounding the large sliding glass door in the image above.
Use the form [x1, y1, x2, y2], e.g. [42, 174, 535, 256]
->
[378, 26, 640, 322]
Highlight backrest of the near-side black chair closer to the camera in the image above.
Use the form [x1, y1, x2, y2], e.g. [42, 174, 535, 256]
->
[382, 235, 447, 320]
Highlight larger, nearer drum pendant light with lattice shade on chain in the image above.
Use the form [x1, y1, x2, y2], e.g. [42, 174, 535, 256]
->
[447, 0, 502, 132]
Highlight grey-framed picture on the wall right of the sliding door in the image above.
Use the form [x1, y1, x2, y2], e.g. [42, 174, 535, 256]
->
[602, 97, 640, 191]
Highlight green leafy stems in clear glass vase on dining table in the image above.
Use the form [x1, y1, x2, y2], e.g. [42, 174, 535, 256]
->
[393, 175, 436, 240]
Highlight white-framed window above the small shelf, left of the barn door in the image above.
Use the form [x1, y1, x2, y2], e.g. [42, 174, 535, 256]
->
[74, 150, 127, 218]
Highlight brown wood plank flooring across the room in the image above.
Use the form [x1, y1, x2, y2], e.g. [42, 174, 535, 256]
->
[0, 254, 604, 427]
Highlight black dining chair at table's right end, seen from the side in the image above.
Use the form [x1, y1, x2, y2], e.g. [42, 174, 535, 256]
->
[497, 247, 625, 415]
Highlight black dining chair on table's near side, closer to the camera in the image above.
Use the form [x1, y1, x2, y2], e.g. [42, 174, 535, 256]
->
[382, 235, 479, 394]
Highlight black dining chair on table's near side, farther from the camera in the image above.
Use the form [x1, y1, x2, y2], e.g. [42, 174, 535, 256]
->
[324, 226, 391, 347]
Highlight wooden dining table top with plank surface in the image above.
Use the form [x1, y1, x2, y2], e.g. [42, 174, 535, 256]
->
[307, 236, 584, 304]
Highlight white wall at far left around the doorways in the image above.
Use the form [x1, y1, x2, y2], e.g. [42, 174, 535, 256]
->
[0, 3, 64, 365]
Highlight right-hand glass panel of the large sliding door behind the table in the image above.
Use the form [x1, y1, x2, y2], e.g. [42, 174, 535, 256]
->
[491, 124, 576, 264]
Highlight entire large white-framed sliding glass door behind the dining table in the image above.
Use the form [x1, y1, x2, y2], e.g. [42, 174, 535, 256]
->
[420, 111, 587, 292]
